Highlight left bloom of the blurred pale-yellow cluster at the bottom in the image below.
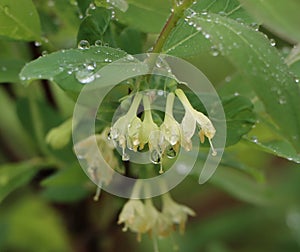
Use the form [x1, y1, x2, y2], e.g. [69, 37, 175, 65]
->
[118, 199, 159, 241]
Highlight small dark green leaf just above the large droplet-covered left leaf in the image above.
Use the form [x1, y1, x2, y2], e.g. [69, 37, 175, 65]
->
[77, 8, 111, 44]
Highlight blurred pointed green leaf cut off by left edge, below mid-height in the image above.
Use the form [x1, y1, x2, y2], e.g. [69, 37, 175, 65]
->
[0, 160, 41, 203]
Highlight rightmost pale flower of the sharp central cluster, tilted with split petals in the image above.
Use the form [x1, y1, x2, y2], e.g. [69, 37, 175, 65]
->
[175, 89, 217, 155]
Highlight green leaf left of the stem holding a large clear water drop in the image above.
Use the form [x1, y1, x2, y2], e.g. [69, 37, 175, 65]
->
[20, 46, 126, 97]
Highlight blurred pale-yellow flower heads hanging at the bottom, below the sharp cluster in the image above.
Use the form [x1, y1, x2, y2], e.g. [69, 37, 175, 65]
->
[118, 193, 195, 241]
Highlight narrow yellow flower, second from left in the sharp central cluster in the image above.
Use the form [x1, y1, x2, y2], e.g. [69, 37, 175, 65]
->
[140, 95, 159, 151]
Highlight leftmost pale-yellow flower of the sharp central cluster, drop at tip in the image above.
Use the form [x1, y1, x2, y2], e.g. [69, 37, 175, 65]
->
[110, 93, 142, 161]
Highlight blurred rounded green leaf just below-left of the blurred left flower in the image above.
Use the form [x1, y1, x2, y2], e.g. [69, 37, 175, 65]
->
[41, 165, 89, 202]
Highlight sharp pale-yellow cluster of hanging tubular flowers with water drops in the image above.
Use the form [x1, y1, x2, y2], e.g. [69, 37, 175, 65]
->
[110, 89, 217, 173]
